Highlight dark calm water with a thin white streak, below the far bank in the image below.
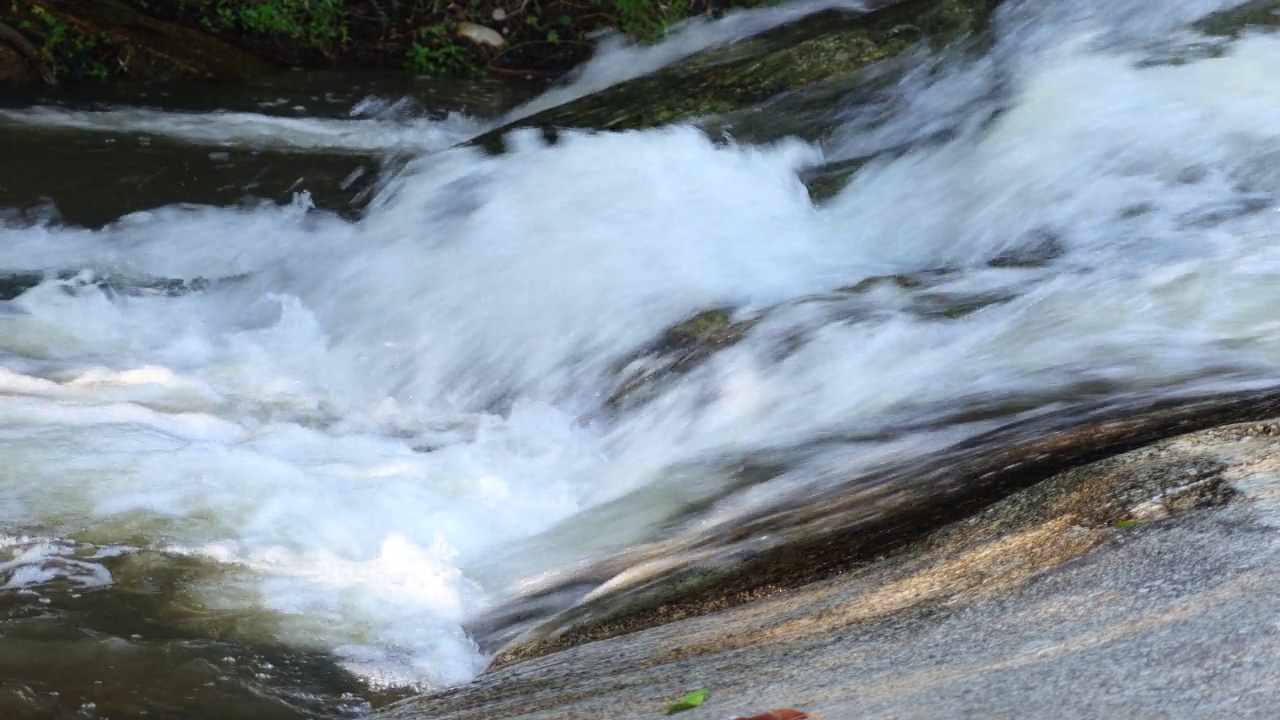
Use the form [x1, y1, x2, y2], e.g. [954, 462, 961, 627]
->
[0, 66, 538, 227]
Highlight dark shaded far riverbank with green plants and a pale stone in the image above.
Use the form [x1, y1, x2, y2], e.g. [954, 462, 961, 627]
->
[0, 0, 777, 85]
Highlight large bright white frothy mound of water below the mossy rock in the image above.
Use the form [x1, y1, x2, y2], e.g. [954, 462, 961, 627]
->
[319, 128, 839, 409]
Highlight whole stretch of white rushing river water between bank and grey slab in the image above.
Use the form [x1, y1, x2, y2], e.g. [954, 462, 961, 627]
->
[0, 0, 1280, 717]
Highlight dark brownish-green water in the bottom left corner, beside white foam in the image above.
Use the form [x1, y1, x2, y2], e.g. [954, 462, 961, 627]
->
[0, 539, 406, 720]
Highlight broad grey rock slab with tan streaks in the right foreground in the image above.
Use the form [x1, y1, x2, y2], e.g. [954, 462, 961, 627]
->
[384, 409, 1280, 719]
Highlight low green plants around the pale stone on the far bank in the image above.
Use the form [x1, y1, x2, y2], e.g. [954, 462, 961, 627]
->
[172, 0, 777, 76]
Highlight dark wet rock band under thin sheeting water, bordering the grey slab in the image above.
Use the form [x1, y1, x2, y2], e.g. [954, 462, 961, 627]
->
[463, 392, 1280, 664]
